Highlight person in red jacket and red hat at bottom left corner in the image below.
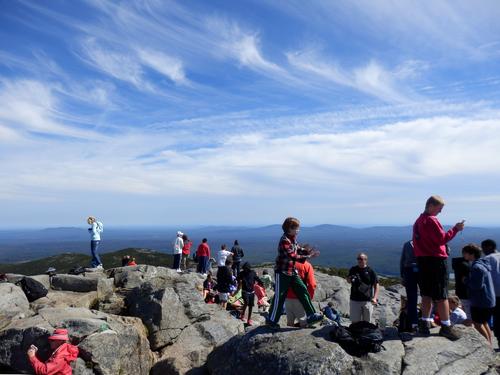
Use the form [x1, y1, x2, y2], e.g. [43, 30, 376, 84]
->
[27, 328, 78, 375]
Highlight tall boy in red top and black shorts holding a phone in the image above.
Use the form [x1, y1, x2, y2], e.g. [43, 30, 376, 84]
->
[413, 195, 464, 341]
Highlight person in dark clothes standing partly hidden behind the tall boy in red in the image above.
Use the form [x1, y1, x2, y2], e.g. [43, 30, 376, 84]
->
[399, 241, 418, 331]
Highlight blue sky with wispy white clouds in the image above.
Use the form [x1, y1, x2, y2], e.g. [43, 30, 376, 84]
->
[0, 0, 500, 228]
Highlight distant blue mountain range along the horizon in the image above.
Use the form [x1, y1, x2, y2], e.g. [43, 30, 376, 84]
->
[0, 224, 500, 275]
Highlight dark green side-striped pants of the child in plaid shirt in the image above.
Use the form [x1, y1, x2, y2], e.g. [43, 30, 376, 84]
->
[269, 272, 316, 324]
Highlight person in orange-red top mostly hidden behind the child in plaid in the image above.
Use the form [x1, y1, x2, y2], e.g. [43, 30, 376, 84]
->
[285, 259, 317, 328]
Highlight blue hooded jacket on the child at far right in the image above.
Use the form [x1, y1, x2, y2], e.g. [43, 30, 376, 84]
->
[466, 259, 495, 308]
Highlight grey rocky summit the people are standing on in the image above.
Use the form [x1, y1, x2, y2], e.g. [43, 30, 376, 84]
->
[0, 265, 500, 375]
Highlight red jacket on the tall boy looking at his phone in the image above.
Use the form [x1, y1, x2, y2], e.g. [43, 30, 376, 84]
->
[413, 212, 458, 258]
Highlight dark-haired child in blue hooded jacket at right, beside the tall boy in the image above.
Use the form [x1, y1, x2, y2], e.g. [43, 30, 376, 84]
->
[462, 244, 495, 346]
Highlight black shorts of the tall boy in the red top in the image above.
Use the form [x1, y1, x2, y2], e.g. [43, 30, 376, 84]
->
[417, 257, 448, 301]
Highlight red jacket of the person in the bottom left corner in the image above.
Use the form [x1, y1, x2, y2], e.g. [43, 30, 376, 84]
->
[29, 343, 78, 375]
